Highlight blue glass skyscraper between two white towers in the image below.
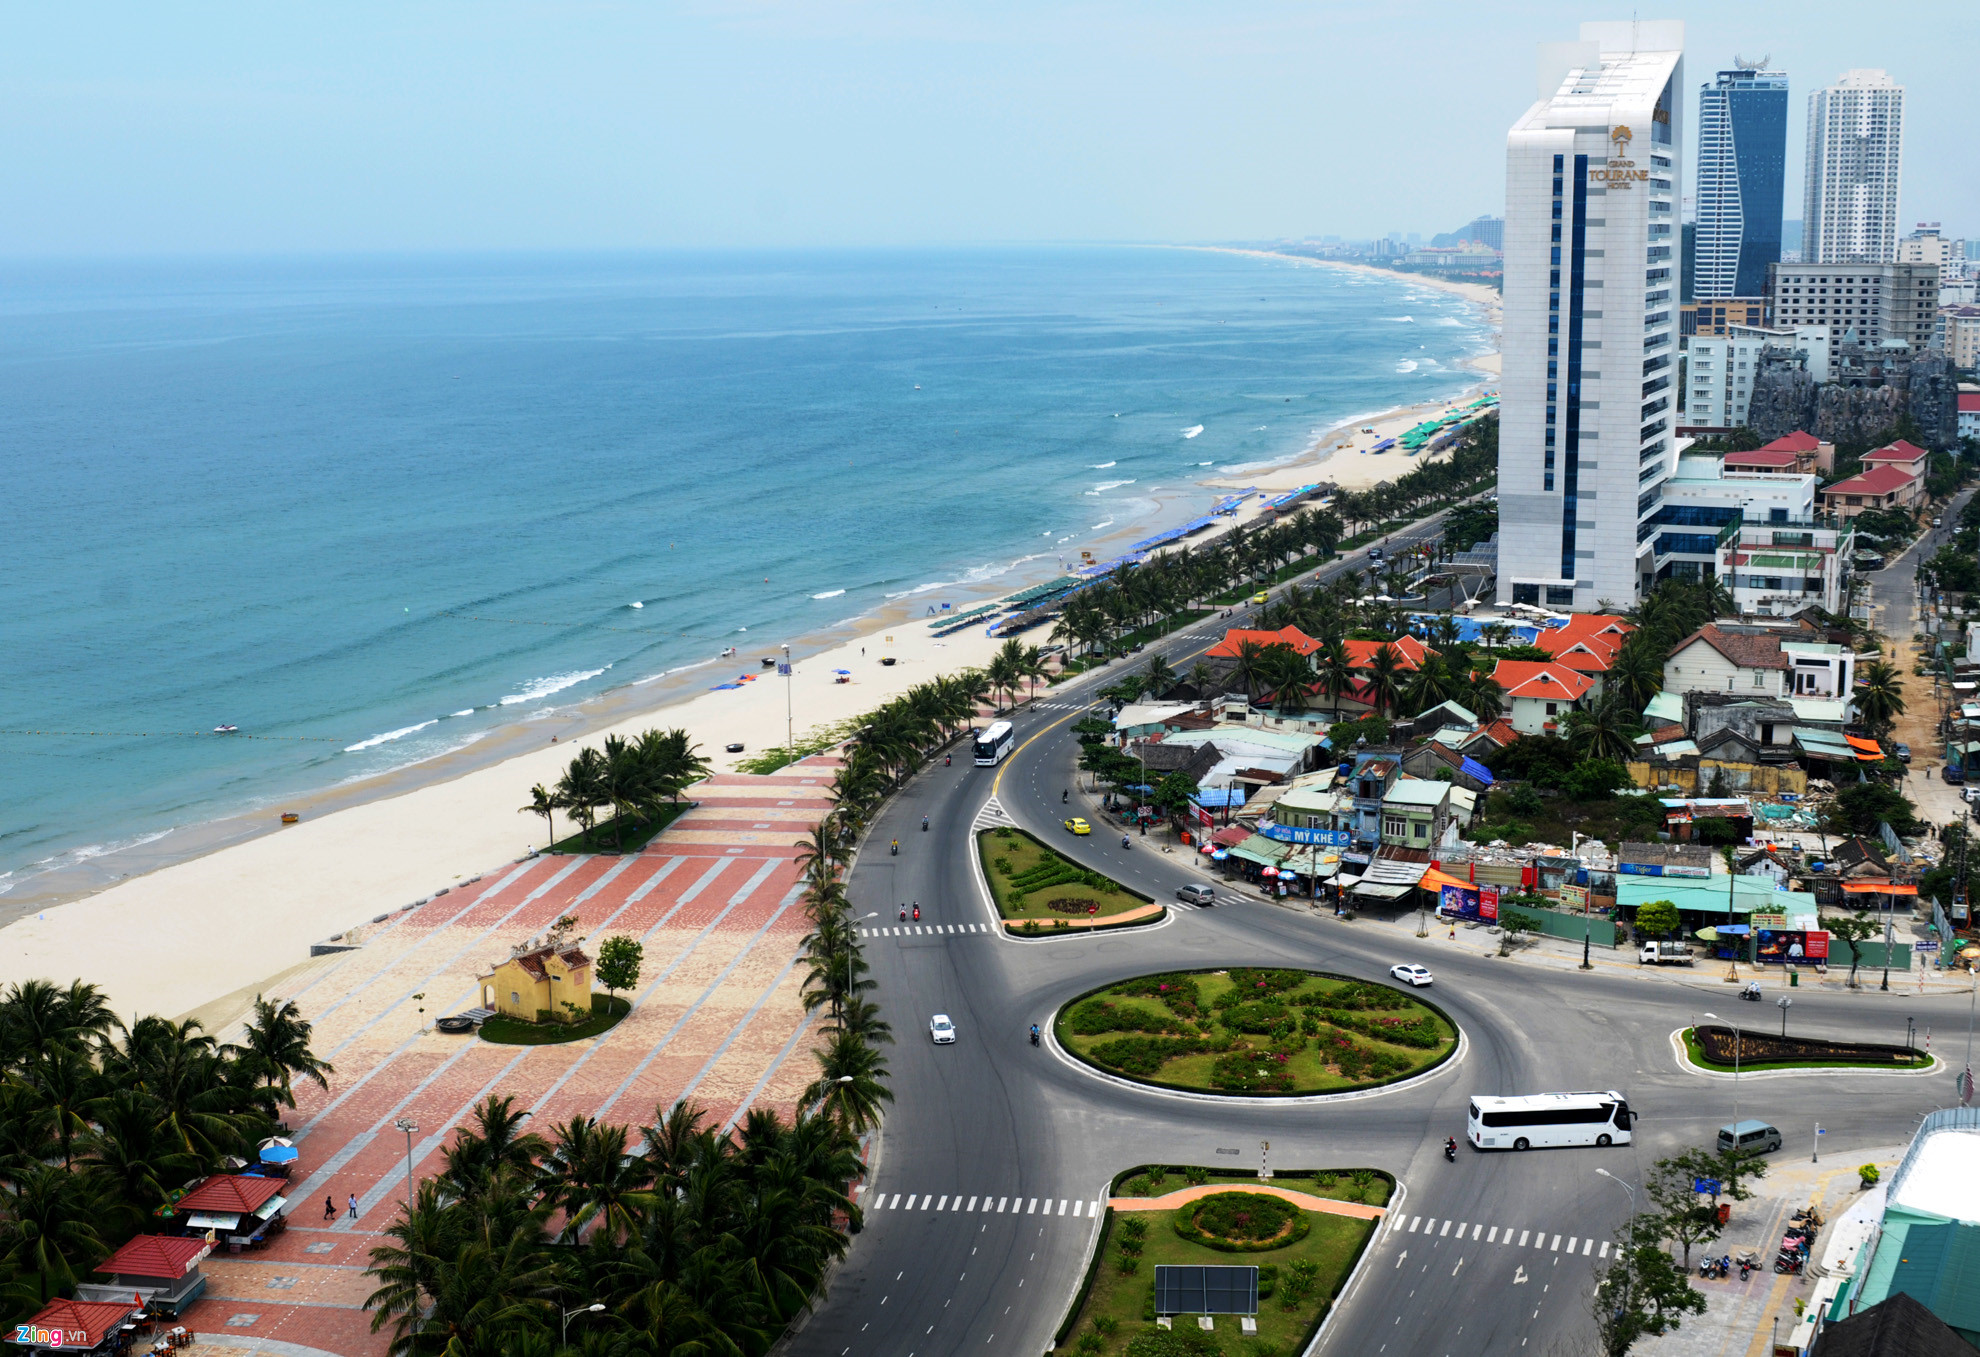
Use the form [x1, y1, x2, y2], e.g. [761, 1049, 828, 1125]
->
[1691, 59, 1788, 299]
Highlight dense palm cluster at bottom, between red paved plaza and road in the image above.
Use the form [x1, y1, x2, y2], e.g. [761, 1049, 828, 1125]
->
[364, 1096, 859, 1357]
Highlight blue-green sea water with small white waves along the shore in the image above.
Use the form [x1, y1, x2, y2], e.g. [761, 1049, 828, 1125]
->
[0, 248, 1487, 893]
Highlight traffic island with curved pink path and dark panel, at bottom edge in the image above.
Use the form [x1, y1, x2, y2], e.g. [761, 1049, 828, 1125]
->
[1053, 1165, 1396, 1357]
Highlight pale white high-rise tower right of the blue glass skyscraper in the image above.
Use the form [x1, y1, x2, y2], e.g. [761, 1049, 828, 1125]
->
[1802, 69, 1905, 263]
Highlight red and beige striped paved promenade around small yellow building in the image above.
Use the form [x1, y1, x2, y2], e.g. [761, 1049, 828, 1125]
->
[186, 759, 836, 1357]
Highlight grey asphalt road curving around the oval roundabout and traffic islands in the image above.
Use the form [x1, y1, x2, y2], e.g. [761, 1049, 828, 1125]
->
[790, 523, 1966, 1357]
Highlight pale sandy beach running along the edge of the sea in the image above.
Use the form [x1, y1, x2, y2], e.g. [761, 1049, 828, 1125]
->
[0, 250, 1497, 1016]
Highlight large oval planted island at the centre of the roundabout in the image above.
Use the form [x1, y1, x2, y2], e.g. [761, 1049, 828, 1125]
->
[1053, 969, 1457, 1096]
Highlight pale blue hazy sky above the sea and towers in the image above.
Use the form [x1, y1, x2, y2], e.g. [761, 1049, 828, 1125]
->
[0, 0, 1980, 256]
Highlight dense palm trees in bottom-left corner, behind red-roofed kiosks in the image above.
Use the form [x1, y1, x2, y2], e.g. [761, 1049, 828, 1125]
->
[0, 981, 331, 1319]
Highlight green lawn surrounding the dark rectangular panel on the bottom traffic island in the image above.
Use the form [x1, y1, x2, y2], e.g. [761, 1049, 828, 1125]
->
[1055, 1183, 1374, 1357]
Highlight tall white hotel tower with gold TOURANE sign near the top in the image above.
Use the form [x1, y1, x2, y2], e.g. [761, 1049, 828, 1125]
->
[1499, 20, 1685, 612]
